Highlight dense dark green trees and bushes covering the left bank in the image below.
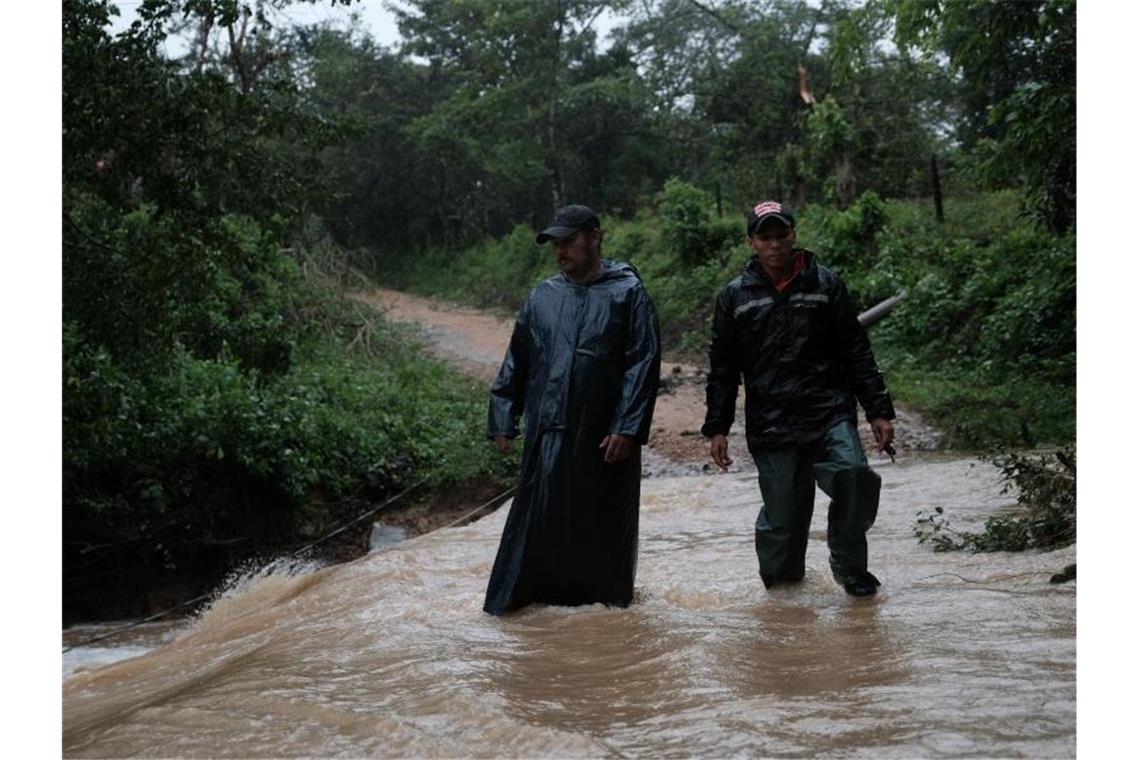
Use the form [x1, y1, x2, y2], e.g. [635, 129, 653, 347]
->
[63, 0, 511, 616]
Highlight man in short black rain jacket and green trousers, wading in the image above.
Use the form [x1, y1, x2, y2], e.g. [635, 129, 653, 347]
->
[701, 201, 895, 596]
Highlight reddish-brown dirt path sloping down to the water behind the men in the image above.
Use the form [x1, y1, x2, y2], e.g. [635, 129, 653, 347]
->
[352, 288, 944, 476]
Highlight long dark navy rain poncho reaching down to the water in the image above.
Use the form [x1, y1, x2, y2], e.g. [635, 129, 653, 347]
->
[483, 261, 661, 615]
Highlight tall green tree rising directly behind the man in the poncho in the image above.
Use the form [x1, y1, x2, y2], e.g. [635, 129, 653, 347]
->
[398, 0, 638, 229]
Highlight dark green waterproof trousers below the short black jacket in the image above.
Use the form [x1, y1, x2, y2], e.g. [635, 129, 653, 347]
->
[751, 422, 880, 587]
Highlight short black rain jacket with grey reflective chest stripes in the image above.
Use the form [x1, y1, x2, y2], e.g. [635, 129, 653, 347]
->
[701, 250, 895, 450]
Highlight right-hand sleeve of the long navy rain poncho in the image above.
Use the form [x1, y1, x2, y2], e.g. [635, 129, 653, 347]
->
[610, 287, 661, 446]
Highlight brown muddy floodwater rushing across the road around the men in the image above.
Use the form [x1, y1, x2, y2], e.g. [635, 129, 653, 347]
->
[64, 452, 1076, 758]
